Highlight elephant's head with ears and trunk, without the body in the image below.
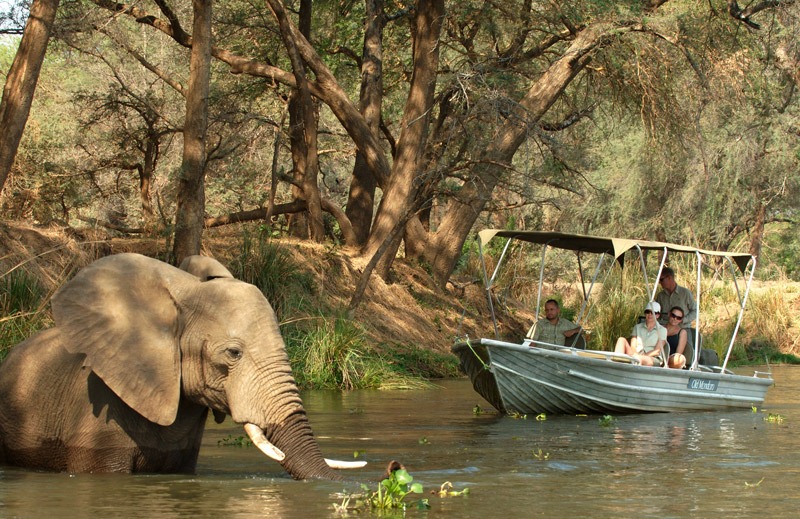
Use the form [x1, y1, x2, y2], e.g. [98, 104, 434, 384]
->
[24, 254, 362, 479]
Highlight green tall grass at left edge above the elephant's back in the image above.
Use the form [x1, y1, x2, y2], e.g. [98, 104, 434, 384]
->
[0, 269, 51, 361]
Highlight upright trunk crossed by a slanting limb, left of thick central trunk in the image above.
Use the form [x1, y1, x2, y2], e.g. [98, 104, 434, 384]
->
[345, 0, 385, 246]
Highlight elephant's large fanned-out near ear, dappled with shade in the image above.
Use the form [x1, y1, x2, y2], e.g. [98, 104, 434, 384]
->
[52, 254, 199, 425]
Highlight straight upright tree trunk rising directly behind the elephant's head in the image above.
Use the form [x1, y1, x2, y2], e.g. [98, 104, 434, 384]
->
[173, 0, 212, 265]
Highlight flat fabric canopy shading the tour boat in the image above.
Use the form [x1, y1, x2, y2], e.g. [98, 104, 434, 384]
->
[478, 229, 753, 272]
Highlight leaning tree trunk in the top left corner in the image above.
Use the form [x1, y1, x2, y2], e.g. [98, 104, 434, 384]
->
[0, 0, 59, 197]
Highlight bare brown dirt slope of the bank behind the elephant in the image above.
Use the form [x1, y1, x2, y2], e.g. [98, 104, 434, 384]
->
[0, 222, 532, 362]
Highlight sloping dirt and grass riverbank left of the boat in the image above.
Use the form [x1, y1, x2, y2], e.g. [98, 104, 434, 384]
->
[0, 222, 533, 387]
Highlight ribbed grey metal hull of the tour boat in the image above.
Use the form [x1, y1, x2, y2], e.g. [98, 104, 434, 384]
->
[453, 339, 773, 414]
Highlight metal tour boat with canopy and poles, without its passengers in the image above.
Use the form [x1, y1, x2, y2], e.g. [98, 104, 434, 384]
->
[452, 229, 774, 415]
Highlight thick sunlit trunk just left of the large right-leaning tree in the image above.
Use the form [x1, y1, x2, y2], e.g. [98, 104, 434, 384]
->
[363, 0, 444, 278]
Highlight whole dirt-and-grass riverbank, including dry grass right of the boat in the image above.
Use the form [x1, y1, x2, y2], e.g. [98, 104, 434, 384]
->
[0, 222, 800, 389]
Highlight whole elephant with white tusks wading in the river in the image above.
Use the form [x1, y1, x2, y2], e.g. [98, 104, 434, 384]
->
[0, 253, 364, 480]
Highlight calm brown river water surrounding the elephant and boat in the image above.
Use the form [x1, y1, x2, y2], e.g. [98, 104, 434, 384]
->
[0, 366, 800, 519]
